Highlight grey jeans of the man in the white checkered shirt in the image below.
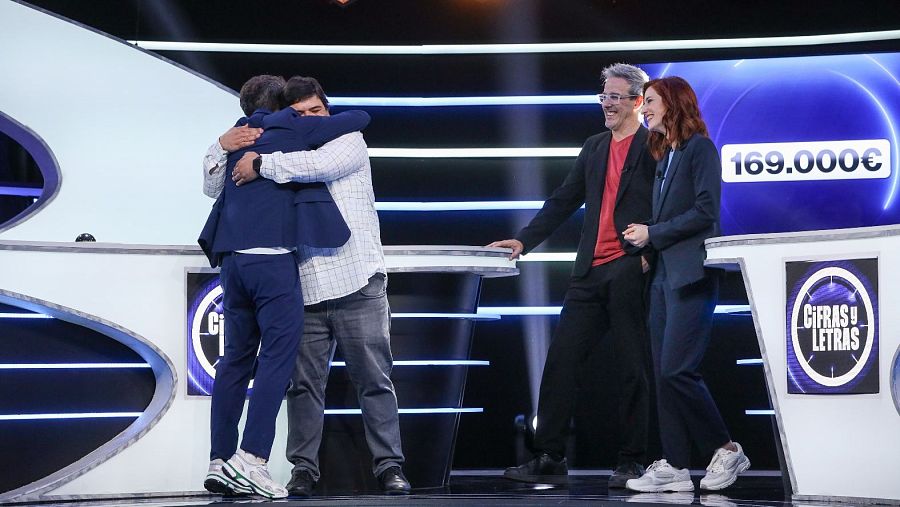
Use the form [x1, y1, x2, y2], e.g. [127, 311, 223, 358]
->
[287, 273, 403, 480]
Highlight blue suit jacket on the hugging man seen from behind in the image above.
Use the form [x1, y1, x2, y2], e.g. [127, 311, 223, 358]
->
[198, 108, 370, 266]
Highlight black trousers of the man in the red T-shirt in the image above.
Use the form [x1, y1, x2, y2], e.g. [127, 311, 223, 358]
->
[534, 255, 650, 463]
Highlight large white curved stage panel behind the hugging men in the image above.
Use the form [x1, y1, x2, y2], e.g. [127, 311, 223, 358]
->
[0, 2, 241, 244]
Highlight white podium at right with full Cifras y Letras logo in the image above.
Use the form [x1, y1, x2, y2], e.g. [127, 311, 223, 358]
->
[706, 225, 900, 503]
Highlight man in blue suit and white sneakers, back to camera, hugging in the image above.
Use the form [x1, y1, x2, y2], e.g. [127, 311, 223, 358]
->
[199, 76, 369, 498]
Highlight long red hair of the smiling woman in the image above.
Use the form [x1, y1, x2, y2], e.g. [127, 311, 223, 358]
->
[644, 76, 709, 160]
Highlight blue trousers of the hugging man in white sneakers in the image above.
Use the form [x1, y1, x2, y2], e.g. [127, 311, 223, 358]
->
[210, 253, 303, 460]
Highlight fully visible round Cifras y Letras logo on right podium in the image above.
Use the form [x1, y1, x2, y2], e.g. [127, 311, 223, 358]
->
[789, 266, 875, 387]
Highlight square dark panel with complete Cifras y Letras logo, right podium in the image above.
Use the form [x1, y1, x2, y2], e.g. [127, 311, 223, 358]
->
[785, 259, 879, 394]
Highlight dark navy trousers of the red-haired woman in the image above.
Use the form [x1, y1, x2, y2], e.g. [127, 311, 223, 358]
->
[649, 257, 731, 468]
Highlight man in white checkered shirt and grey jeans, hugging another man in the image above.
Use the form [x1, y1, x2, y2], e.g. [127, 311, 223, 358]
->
[204, 78, 410, 496]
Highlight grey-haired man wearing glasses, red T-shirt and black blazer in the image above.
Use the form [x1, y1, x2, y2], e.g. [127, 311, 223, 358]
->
[488, 63, 656, 488]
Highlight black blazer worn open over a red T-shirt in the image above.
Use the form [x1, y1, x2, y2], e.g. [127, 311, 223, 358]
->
[516, 126, 656, 277]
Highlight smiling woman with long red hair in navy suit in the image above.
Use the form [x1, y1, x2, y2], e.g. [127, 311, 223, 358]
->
[625, 77, 750, 492]
